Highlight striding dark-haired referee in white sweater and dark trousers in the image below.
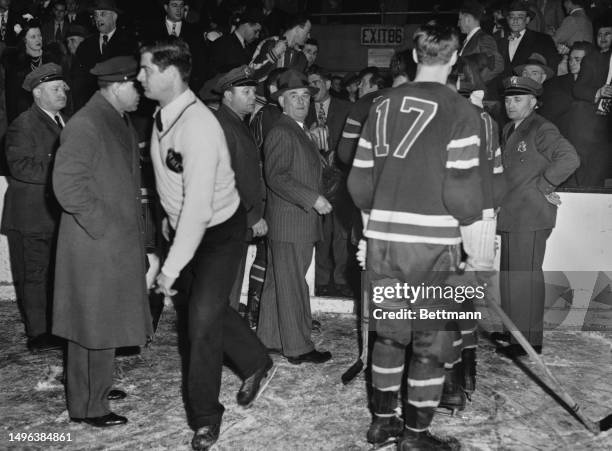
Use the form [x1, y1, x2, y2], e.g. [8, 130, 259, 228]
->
[138, 40, 272, 451]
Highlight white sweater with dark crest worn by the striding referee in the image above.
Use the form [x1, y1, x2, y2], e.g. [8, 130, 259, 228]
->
[151, 89, 240, 277]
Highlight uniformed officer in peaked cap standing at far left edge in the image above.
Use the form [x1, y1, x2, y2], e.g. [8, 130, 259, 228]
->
[2, 63, 68, 351]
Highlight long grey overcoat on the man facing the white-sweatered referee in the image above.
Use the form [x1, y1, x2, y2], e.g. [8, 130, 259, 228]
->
[53, 92, 151, 349]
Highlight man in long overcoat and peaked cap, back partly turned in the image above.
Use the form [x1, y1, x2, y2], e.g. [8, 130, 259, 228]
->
[53, 57, 152, 427]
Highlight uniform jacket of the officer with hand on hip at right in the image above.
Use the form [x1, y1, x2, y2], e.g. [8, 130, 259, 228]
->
[497, 113, 580, 232]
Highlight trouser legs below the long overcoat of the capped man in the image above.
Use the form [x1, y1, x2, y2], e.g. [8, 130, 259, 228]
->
[66, 341, 115, 418]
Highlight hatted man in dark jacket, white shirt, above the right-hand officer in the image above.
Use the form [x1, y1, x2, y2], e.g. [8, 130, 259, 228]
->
[497, 0, 561, 82]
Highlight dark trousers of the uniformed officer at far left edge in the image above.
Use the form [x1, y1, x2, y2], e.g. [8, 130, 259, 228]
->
[7, 230, 55, 338]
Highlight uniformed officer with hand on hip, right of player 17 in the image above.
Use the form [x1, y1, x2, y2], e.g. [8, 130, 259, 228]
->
[493, 77, 580, 357]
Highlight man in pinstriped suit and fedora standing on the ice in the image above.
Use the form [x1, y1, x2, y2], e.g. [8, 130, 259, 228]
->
[257, 69, 332, 364]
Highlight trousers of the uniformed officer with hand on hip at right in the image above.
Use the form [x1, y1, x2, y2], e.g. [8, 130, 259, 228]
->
[499, 229, 552, 346]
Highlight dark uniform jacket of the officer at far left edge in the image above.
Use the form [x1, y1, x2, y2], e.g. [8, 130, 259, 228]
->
[2, 104, 61, 235]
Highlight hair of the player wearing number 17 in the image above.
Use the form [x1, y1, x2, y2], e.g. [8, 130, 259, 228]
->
[413, 25, 459, 66]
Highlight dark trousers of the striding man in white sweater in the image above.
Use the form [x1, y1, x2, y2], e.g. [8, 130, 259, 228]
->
[178, 207, 269, 429]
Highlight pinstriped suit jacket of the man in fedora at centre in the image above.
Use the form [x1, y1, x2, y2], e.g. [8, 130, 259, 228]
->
[264, 114, 323, 243]
